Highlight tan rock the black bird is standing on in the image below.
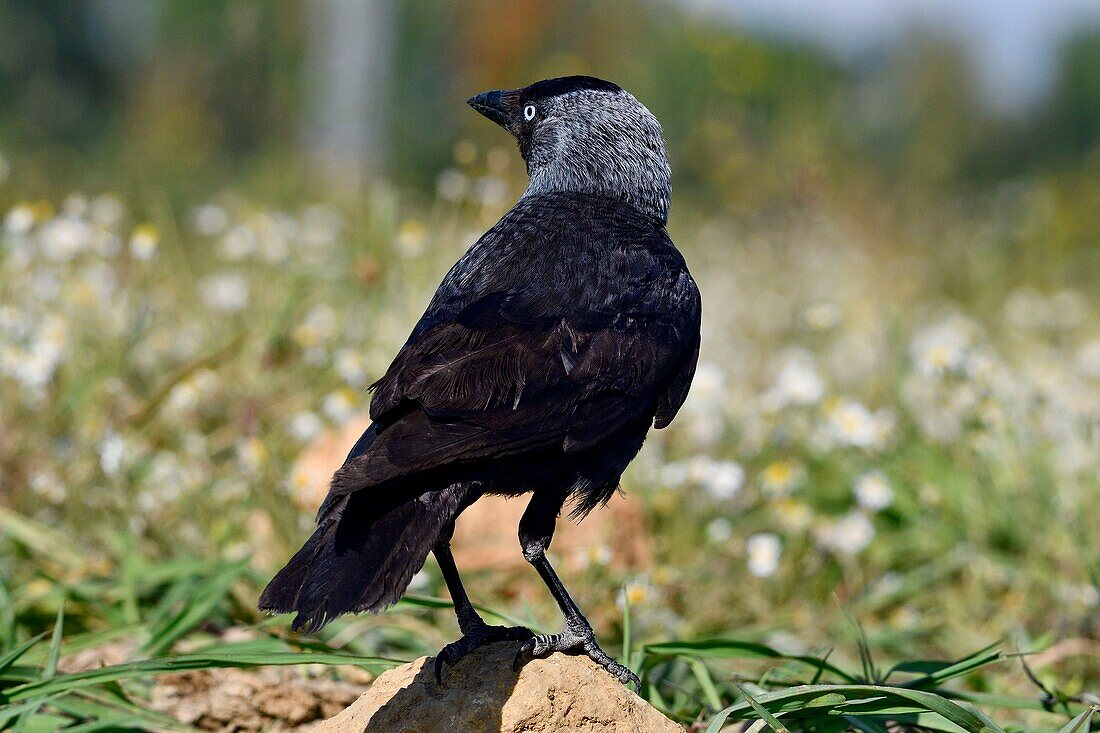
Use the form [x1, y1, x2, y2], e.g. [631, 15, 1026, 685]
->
[314, 643, 684, 733]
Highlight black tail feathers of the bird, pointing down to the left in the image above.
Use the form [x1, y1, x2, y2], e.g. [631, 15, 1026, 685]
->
[260, 484, 468, 633]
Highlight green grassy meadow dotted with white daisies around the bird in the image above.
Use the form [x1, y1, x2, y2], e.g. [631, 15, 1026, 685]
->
[0, 158, 1100, 733]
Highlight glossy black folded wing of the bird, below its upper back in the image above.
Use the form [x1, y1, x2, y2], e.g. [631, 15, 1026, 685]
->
[332, 202, 699, 494]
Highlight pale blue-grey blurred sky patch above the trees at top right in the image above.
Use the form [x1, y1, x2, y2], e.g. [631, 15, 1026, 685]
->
[679, 0, 1100, 114]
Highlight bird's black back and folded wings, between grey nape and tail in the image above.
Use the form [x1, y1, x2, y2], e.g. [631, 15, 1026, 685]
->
[332, 195, 700, 495]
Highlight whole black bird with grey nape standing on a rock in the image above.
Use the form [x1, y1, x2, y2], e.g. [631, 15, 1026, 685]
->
[260, 76, 700, 682]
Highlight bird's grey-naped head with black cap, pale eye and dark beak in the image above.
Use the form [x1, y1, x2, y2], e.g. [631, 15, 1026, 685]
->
[469, 76, 672, 222]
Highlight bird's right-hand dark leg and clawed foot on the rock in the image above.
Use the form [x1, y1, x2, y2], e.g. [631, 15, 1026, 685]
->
[513, 492, 640, 685]
